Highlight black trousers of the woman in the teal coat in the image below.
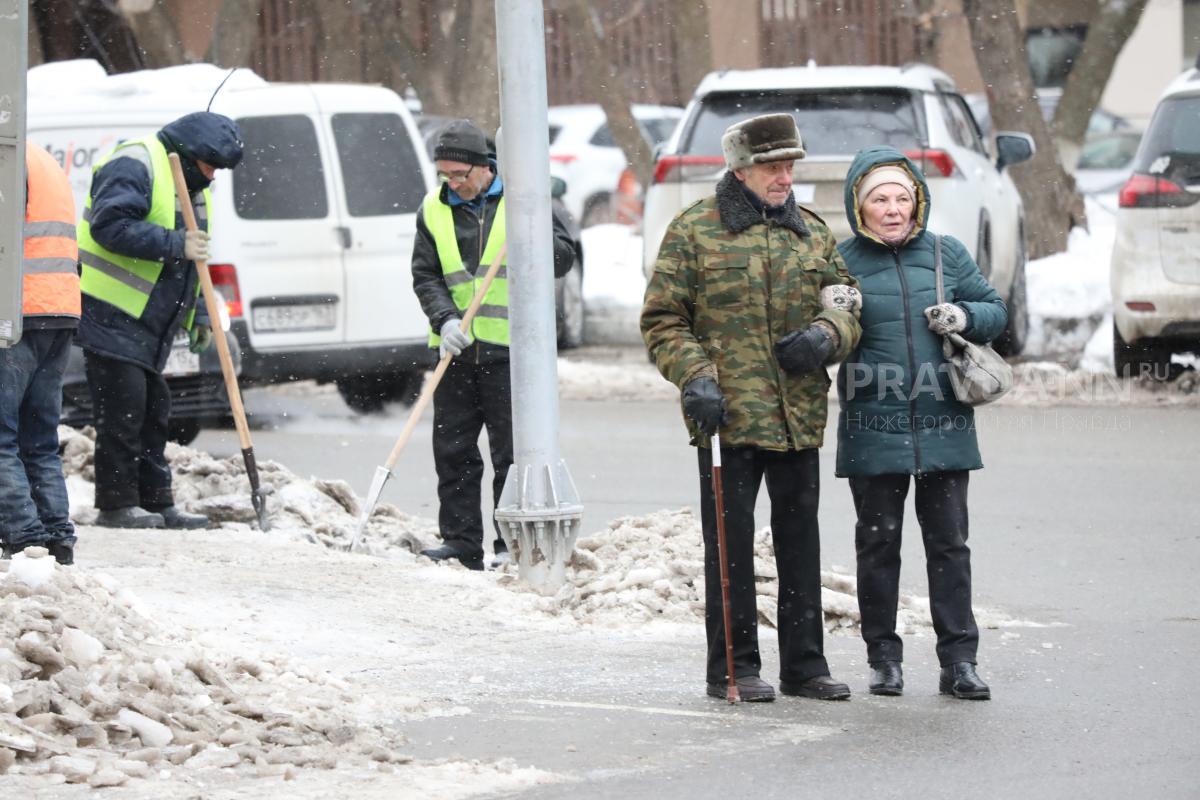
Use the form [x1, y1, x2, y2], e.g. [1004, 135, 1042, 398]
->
[850, 470, 979, 667]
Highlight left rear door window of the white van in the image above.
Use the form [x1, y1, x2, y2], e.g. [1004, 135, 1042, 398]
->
[233, 114, 329, 219]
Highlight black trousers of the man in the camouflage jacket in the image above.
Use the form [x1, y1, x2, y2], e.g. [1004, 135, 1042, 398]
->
[697, 447, 829, 684]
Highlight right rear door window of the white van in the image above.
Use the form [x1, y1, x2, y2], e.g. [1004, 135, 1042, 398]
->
[332, 114, 425, 217]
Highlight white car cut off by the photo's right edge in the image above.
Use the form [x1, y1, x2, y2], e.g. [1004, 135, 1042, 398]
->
[1111, 65, 1200, 378]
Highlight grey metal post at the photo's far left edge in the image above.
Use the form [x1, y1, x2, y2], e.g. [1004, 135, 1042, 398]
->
[0, 0, 29, 348]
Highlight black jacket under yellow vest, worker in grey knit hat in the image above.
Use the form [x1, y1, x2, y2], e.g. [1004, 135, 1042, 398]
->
[413, 181, 575, 363]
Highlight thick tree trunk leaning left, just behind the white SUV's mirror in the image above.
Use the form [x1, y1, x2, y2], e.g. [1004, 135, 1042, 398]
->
[962, 0, 1086, 258]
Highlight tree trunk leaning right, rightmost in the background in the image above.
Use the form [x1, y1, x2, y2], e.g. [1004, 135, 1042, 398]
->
[1051, 0, 1147, 169]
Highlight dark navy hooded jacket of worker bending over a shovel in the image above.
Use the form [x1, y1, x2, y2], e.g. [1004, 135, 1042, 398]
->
[77, 114, 241, 372]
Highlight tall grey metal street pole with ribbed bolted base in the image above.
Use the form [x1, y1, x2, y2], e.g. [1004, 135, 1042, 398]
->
[496, 0, 583, 590]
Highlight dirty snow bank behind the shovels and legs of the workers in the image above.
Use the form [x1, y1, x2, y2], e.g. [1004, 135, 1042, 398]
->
[59, 426, 437, 558]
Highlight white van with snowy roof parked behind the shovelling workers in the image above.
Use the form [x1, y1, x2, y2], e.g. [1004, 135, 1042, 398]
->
[28, 61, 434, 422]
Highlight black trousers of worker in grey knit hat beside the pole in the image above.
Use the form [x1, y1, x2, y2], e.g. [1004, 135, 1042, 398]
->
[433, 360, 512, 558]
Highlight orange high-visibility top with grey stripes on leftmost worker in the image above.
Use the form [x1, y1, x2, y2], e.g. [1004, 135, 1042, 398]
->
[23, 142, 79, 318]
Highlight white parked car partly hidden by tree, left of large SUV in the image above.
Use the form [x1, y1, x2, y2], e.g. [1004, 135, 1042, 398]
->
[547, 104, 683, 228]
